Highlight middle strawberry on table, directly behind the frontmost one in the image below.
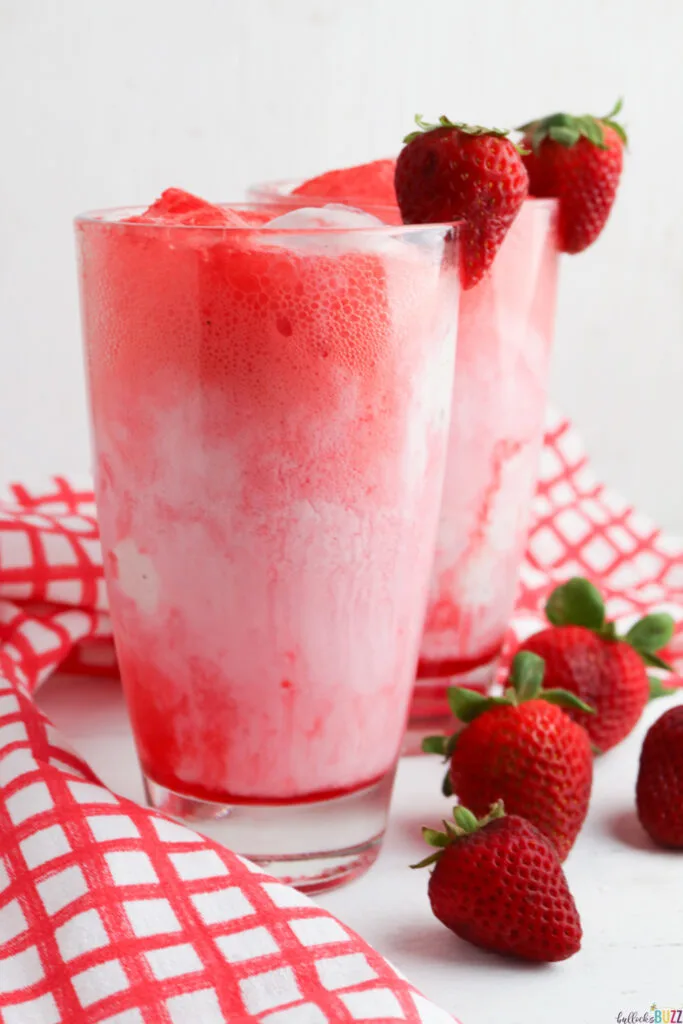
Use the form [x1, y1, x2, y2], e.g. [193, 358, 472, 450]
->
[423, 652, 593, 860]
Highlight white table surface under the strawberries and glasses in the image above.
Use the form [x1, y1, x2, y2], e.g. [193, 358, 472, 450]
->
[38, 678, 683, 1024]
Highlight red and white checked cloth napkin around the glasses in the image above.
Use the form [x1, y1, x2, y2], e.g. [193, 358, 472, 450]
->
[0, 409, 683, 1024]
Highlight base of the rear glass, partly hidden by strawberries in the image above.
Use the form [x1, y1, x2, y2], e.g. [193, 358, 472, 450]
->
[401, 655, 499, 757]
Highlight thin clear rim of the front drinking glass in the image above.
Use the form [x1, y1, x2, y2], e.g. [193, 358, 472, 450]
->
[74, 201, 465, 237]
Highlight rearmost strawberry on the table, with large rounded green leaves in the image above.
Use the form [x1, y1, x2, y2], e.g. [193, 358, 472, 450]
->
[520, 577, 674, 753]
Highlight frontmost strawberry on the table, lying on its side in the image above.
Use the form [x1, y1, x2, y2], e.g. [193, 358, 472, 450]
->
[415, 802, 582, 962]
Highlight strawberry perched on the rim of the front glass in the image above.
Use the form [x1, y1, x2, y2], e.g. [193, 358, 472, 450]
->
[395, 116, 528, 288]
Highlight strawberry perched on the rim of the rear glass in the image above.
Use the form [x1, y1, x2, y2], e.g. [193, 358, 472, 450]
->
[519, 100, 627, 253]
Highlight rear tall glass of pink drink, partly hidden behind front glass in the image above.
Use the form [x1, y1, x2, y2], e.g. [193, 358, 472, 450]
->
[250, 181, 558, 753]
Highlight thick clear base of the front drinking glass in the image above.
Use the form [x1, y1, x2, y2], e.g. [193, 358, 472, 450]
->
[142, 766, 395, 893]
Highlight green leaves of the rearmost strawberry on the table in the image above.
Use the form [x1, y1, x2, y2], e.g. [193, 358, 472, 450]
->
[546, 577, 675, 672]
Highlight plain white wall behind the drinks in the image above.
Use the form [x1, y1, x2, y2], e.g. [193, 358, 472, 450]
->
[0, 0, 683, 530]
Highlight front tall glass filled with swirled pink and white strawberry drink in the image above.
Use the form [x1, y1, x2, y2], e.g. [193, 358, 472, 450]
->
[77, 189, 459, 889]
